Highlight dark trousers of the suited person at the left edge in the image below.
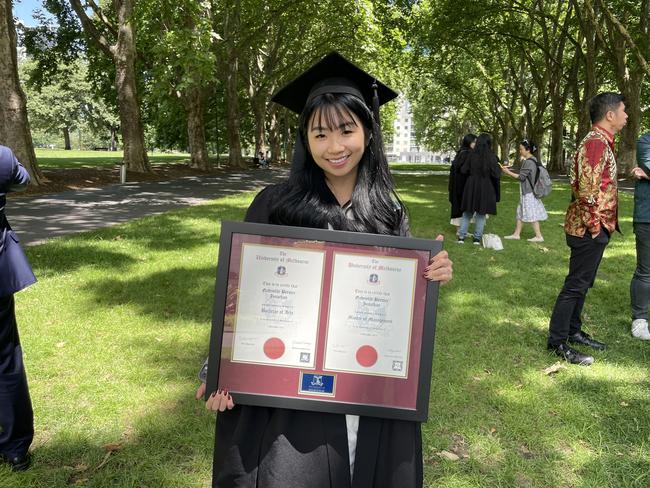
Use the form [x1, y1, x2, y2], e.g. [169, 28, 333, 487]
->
[0, 295, 34, 458]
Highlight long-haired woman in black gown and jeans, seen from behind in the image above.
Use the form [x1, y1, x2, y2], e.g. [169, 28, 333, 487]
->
[458, 134, 501, 245]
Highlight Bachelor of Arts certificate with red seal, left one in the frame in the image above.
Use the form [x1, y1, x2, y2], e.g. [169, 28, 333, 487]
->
[232, 243, 325, 368]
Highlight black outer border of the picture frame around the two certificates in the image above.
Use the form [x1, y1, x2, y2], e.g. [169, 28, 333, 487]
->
[205, 221, 443, 422]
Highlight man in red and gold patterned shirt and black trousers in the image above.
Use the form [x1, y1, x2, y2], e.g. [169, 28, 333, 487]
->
[548, 92, 627, 366]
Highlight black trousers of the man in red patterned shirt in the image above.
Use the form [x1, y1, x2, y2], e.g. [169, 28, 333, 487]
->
[548, 230, 609, 346]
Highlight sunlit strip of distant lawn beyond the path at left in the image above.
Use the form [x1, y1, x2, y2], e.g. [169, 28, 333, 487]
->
[36, 149, 189, 169]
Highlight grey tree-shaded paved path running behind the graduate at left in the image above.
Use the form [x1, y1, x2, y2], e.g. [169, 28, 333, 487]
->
[5, 169, 288, 246]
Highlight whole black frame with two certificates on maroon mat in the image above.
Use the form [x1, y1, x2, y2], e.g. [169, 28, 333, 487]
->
[206, 222, 442, 421]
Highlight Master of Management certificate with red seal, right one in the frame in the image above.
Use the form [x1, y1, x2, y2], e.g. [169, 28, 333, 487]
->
[325, 252, 418, 378]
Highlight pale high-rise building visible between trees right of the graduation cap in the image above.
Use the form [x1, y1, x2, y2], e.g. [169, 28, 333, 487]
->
[386, 96, 448, 163]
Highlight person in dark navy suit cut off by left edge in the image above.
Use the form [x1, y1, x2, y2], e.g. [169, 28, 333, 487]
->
[0, 146, 36, 471]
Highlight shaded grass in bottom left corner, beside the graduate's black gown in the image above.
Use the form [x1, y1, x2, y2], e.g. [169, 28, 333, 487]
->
[0, 389, 215, 488]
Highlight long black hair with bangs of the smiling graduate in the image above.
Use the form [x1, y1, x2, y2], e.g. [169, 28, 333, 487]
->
[271, 93, 406, 235]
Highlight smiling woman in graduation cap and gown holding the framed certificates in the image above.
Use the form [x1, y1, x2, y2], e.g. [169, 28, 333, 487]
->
[197, 53, 452, 488]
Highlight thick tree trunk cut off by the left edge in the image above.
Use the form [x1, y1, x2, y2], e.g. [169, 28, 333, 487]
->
[0, 0, 44, 185]
